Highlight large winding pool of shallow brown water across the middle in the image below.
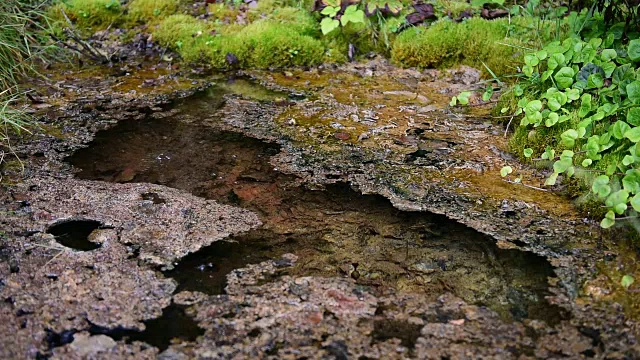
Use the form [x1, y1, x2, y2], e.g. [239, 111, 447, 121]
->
[67, 86, 559, 323]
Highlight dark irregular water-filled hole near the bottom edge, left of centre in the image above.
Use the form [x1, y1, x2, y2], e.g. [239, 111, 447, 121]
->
[89, 304, 205, 351]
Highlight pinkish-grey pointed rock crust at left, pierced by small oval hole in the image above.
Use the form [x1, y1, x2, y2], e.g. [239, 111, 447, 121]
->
[0, 178, 260, 358]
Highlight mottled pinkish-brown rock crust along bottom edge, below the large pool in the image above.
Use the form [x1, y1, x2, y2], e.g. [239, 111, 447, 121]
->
[161, 255, 599, 359]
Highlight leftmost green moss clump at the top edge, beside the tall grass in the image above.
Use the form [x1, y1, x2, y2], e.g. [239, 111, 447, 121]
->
[48, 0, 122, 32]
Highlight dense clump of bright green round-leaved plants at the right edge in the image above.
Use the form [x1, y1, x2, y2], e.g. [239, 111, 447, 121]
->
[513, 23, 640, 228]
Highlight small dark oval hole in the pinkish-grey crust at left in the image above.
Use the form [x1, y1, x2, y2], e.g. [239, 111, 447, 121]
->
[47, 220, 102, 251]
